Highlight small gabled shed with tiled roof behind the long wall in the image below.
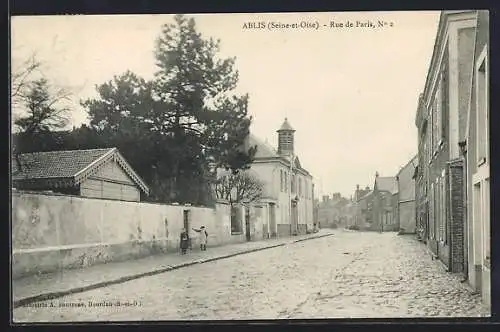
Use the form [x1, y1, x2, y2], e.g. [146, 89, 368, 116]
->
[12, 148, 150, 201]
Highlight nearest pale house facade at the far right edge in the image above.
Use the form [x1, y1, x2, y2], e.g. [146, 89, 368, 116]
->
[460, 10, 491, 305]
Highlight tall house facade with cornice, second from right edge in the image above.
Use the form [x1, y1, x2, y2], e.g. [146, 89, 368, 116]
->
[415, 10, 477, 280]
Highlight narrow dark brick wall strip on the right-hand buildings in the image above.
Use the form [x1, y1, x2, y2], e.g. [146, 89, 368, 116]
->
[448, 160, 464, 272]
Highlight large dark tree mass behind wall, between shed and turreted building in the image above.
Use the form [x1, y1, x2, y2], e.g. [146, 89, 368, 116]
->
[82, 15, 255, 203]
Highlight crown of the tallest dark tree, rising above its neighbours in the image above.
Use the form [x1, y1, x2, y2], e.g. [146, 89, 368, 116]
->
[151, 15, 255, 176]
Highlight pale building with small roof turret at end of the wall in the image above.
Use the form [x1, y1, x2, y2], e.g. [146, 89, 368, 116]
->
[241, 119, 314, 237]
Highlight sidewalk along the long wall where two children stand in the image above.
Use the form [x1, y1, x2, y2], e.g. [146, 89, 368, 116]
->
[12, 229, 334, 308]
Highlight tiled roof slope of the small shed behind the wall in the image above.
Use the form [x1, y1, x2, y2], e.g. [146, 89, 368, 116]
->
[12, 148, 113, 180]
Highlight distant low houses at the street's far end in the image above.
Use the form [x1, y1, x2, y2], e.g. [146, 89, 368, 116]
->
[316, 156, 417, 234]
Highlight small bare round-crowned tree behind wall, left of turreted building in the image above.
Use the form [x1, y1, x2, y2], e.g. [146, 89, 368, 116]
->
[215, 172, 264, 205]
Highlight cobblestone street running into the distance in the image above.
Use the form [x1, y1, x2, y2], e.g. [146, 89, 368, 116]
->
[13, 231, 488, 322]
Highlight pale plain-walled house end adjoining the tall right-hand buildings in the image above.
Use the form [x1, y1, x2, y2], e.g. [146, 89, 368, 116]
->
[396, 156, 418, 234]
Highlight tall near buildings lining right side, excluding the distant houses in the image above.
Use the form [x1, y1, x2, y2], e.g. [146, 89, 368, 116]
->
[415, 10, 491, 304]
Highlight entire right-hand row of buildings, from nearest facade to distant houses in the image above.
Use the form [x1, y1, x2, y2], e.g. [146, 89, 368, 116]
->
[315, 10, 491, 305]
